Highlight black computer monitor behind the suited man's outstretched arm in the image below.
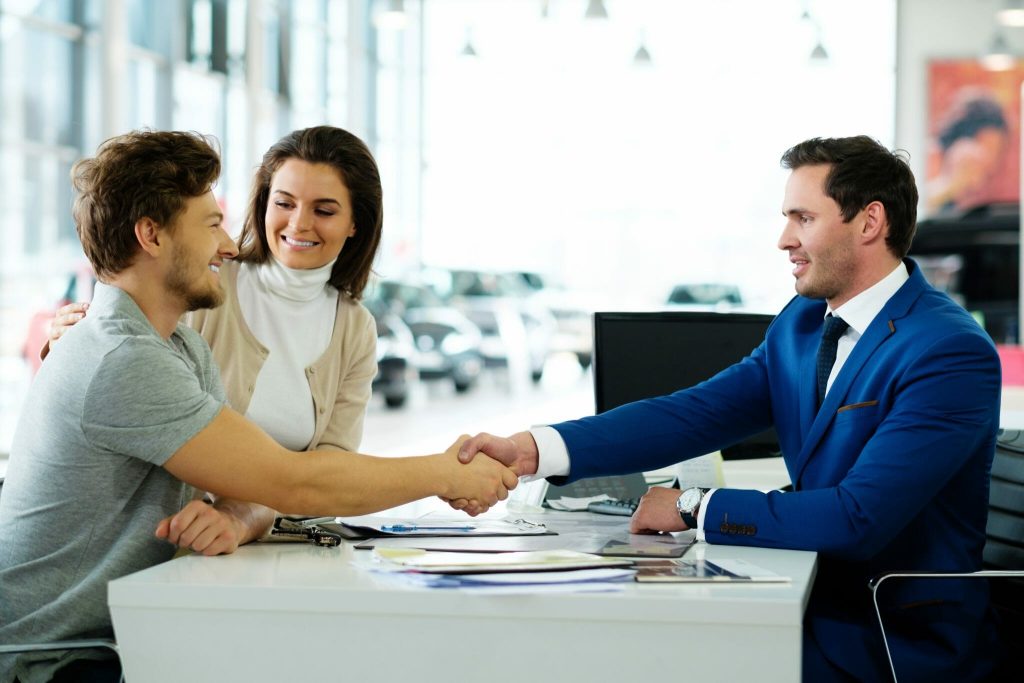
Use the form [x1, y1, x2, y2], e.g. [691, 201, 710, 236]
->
[594, 311, 780, 460]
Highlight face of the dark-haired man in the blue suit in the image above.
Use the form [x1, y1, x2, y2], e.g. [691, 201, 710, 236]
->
[778, 164, 863, 308]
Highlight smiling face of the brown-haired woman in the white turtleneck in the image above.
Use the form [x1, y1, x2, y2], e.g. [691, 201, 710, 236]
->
[265, 159, 355, 269]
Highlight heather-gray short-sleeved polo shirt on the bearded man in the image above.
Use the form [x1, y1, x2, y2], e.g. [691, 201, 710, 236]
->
[0, 284, 224, 683]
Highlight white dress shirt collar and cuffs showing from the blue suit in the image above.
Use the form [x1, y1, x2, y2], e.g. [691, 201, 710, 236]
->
[522, 261, 910, 541]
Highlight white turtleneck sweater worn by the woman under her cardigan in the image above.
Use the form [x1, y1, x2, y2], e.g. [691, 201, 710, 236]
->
[238, 258, 338, 451]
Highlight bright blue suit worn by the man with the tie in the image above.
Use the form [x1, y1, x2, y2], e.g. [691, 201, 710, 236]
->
[553, 259, 1000, 681]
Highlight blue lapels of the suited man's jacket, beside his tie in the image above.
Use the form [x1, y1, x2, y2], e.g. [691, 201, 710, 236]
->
[791, 259, 929, 483]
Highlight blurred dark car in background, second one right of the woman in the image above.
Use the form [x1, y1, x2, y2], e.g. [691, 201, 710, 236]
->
[368, 280, 483, 393]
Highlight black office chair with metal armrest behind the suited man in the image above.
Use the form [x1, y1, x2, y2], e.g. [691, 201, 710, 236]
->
[870, 430, 1024, 681]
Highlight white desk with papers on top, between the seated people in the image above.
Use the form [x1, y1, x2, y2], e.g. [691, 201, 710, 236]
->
[110, 512, 816, 683]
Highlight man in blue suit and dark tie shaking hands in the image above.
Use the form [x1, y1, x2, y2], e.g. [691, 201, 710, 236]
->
[453, 136, 1000, 682]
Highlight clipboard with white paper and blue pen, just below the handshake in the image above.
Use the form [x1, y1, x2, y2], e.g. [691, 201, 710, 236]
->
[321, 516, 555, 540]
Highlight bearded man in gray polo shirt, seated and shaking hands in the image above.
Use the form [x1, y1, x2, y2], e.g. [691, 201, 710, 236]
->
[0, 132, 516, 683]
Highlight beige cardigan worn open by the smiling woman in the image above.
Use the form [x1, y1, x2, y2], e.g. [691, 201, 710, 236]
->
[185, 261, 377, 451]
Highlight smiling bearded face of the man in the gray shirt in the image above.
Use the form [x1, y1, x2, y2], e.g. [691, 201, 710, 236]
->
[164, 191, 238, 310]
